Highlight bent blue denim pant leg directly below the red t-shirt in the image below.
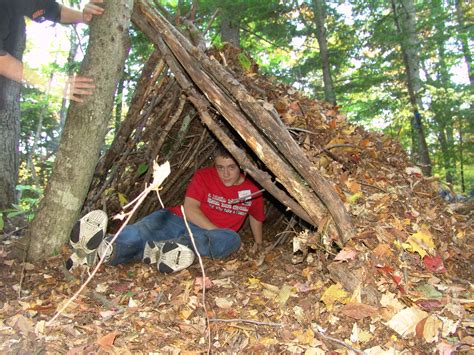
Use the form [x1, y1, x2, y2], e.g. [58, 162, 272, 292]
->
[177, 227, 240, 259]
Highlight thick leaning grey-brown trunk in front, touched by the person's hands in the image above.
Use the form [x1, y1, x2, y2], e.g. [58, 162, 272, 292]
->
[28, 0, 133, 260]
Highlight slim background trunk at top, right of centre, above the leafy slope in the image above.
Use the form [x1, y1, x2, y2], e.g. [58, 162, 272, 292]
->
[313, 0, 336, 105]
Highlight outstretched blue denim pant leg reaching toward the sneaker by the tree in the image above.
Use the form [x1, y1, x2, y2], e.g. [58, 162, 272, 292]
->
[108, 209, 186, 265]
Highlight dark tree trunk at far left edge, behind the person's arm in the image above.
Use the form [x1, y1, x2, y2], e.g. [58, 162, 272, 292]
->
[0, 18, 25, 210]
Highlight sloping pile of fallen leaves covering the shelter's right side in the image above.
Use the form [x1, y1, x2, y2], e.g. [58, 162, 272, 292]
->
[213, 48, 474, 352]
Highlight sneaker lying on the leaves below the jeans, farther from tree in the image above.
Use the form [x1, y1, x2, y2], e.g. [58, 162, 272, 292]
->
[143, 240, 194, 274]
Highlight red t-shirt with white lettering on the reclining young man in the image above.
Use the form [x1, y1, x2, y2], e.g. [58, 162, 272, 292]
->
[169, 167, 265, 231]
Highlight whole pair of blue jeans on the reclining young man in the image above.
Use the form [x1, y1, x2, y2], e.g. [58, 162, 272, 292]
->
[107, 209, 240, 265]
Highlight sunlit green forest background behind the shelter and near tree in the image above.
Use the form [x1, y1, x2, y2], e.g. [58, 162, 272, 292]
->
[0, 0, 474, 230]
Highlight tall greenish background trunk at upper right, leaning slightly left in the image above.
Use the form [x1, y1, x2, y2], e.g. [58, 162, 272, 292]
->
[392, 0, 431, 176]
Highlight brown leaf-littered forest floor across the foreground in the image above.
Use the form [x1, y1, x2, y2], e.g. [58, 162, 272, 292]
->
[0, 222, 474, 354]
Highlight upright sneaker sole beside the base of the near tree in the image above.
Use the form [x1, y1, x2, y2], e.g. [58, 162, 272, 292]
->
[66, 210, 107, 270]
